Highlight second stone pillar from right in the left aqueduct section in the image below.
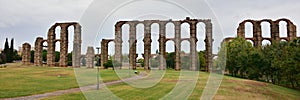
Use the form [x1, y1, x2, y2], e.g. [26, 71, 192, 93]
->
[59, 24, 68, 67]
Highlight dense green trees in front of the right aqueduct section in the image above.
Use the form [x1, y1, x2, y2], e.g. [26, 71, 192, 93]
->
[214, 38, 300, 88]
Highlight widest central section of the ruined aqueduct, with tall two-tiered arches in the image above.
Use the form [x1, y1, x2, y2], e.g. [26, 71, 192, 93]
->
[101, 17, 213, 71]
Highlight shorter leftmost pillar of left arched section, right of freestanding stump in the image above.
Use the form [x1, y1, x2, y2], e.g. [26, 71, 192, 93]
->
[34, 37, 43, 66]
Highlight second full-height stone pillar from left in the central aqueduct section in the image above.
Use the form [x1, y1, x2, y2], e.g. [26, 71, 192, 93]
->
[128, 22, 137, 70]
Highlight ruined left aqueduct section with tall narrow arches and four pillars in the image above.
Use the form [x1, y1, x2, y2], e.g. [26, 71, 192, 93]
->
[34, 22, 81, 67]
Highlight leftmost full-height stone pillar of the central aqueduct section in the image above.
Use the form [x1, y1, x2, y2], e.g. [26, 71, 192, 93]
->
[114, 22, 123, 66]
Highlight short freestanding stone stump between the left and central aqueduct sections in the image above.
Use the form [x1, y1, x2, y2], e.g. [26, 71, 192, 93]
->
[86, 47, 95, 68]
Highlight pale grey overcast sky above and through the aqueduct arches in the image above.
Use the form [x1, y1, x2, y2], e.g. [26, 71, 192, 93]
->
[0, 0, 300, 53]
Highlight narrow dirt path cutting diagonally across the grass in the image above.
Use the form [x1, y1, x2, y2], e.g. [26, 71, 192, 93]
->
[0, 75, 143, 100]
